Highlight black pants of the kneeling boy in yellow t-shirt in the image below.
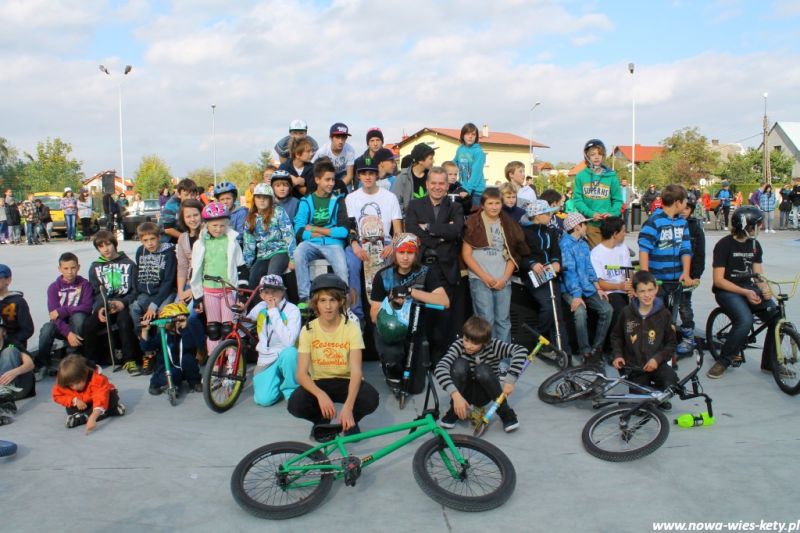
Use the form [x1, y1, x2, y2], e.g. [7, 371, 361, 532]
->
[287, 378, 380, 424]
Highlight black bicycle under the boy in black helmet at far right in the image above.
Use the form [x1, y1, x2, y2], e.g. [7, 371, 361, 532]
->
[706, 274, 800, 395]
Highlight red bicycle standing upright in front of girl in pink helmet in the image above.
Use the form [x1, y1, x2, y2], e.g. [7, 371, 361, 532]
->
[203, 276, 260, 413]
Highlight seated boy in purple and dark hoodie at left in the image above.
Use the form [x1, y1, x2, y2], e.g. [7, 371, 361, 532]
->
[34, 252, 92, 381]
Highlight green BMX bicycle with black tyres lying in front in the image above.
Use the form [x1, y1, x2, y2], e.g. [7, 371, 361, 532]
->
[231, 341, 516, 519]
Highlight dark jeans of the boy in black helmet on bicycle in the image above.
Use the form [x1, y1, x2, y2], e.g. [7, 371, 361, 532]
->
[714, 290, 780, 369]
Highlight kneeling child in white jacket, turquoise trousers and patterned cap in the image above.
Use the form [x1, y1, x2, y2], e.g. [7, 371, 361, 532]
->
[247, 274, 301, 406]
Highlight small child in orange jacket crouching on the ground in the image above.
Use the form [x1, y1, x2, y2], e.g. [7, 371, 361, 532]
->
[53, 354, 125, 433]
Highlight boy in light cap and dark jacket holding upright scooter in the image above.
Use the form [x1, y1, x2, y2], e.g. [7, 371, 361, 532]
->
[522, 200, 570, 359]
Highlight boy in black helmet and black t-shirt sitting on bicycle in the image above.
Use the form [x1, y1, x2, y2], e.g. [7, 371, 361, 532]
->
[707, 206, 779, 379]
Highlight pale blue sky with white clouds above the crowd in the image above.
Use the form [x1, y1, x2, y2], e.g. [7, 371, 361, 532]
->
[0, 0, 800, 179]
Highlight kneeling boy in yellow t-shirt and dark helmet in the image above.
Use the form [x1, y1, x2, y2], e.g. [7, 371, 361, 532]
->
[288, 274, 378, 435]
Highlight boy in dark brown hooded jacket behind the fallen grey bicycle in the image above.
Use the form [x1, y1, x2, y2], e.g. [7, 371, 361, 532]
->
[611, 270, 678, 410]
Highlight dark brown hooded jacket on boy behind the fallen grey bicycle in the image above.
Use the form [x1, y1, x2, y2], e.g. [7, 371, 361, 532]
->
[611, 298, 677, 367]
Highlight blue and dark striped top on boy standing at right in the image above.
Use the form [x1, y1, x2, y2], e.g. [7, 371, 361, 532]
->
[639, 209, 692, 281]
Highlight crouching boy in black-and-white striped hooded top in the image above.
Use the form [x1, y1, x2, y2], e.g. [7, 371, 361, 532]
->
[434, 316, 528, 433]
